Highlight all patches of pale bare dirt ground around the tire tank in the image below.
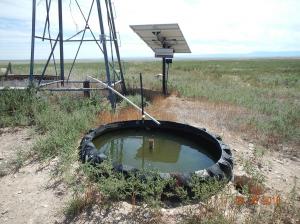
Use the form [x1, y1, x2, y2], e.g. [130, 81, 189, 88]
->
[0, 96, 300, 223]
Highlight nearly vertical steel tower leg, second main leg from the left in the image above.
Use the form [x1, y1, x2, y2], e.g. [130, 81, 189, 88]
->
[58, 0, 65, 86]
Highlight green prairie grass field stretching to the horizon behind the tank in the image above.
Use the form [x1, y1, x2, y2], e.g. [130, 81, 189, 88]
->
[2, 59, 300, 148]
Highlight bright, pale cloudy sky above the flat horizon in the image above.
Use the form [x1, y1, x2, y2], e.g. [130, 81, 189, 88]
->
[0, 0, 300, 60]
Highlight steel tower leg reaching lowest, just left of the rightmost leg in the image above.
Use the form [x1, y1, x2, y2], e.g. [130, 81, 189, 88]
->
[96, 0, 115, 109]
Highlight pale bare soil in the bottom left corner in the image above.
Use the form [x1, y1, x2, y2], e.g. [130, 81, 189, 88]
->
[0, 128, 67, 224]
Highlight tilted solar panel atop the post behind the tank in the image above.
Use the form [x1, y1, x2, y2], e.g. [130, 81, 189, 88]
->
[130, 23, 191, 53]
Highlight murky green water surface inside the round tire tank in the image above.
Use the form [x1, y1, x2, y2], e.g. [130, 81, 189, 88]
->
[93, 130, 215, 173]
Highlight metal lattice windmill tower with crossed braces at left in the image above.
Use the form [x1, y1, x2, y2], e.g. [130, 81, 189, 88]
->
[29, 0, 126, 105]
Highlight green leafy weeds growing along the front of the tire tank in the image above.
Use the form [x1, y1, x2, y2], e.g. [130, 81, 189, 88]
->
[78, 160, 225, 207]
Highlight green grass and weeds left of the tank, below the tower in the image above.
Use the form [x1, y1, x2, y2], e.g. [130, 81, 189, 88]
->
[0, 89, 107, 175]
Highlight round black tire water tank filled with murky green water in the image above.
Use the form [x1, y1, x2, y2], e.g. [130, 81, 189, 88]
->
[79, 120, 233, 182]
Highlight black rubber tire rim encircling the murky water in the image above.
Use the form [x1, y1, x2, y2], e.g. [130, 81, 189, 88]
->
[79, 120, 233, 183]
